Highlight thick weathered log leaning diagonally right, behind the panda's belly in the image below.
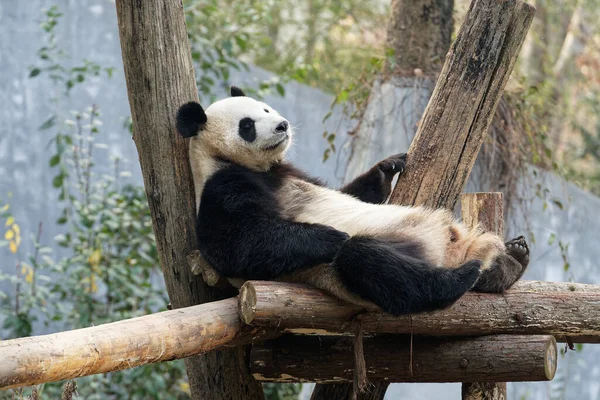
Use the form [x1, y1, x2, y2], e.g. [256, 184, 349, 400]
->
[391, 0, 535, 208]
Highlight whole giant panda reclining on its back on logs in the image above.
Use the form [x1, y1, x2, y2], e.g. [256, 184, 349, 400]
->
[176, 87, 529, 315]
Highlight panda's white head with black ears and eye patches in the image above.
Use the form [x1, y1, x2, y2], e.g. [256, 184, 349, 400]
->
[177, 86, 292, 170]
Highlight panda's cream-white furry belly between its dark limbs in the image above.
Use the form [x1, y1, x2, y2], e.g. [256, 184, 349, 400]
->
[278, 180, 454, 265]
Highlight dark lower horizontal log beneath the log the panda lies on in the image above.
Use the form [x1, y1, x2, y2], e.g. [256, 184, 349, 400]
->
[250, 335, 557, 383]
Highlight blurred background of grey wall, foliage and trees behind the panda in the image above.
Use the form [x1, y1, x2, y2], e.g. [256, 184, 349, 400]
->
[0, 0, 600, 400]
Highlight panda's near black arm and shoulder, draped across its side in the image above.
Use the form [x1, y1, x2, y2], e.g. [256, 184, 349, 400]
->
[197, 167, 349, 279]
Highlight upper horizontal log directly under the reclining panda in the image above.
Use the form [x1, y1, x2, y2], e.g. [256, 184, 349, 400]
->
[239, 281, 600, 343]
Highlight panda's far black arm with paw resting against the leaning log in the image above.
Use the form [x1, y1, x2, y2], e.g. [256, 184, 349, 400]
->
[340, 154, 406, 204]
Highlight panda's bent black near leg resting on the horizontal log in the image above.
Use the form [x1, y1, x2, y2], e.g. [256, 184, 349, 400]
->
[334, 236, 481, 315]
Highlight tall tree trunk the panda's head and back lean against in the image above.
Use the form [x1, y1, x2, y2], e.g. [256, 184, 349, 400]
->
[116, 0, 263, 399]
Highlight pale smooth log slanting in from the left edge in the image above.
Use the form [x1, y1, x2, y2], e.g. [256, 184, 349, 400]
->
[0, 298, 274, 389]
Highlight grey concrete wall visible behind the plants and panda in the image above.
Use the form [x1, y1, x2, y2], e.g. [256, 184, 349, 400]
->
[0, 0, 600, 400]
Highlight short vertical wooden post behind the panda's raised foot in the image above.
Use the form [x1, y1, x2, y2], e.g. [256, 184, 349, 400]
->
[460, 192, 506, 400]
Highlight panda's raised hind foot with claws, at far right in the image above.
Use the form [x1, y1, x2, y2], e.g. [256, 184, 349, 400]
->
[473, 236, 529, 293]
